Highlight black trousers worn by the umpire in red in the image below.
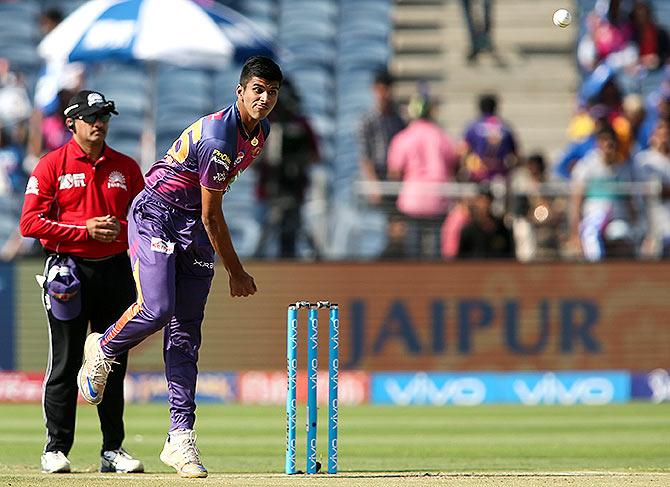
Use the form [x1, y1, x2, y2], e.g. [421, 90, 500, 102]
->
[42, 253, 135, 455]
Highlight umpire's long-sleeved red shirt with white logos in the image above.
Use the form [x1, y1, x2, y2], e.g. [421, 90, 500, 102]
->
[20, 139, 144, 259]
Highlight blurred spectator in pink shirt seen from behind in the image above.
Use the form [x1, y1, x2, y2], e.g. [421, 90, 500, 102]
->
[387, 93, 459, 259]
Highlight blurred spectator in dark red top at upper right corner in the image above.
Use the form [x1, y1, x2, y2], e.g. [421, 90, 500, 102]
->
[630, 0, 670, 71]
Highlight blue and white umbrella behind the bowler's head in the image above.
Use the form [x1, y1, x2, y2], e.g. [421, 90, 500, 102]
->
[38, 0, 234, 68]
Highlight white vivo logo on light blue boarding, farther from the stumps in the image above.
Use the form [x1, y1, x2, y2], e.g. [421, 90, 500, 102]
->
[513, 372, 614, 406]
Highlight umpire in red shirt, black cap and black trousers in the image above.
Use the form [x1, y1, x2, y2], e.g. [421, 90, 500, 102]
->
[20, 91, 144, 473]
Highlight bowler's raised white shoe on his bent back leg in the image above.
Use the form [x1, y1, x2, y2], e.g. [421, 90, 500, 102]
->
[77, 333, 118, 404]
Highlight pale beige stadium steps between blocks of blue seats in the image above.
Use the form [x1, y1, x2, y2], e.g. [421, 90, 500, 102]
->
[391, 0, 578, 156]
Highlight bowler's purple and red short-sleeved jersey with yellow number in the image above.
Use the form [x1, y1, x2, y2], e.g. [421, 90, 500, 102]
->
[144, 103, 270, 216]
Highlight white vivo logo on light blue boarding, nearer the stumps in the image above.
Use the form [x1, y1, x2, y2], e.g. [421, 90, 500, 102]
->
[384, 372, 486, 406]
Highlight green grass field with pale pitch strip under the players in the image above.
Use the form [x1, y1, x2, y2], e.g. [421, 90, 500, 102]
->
[0, 403, 670, 487]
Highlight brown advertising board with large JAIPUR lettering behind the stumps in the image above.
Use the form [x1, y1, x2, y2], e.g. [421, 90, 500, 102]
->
[9, 261, 670, 371]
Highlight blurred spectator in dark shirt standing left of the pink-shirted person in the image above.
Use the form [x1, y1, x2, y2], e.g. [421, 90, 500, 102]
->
[358, 70, 405, 205]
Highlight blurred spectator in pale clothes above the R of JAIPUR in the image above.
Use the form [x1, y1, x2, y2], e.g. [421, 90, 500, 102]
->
[568, 126, 636, 261]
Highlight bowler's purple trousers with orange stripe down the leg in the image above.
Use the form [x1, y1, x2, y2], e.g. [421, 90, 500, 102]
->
[101, 190, 214, 431]
